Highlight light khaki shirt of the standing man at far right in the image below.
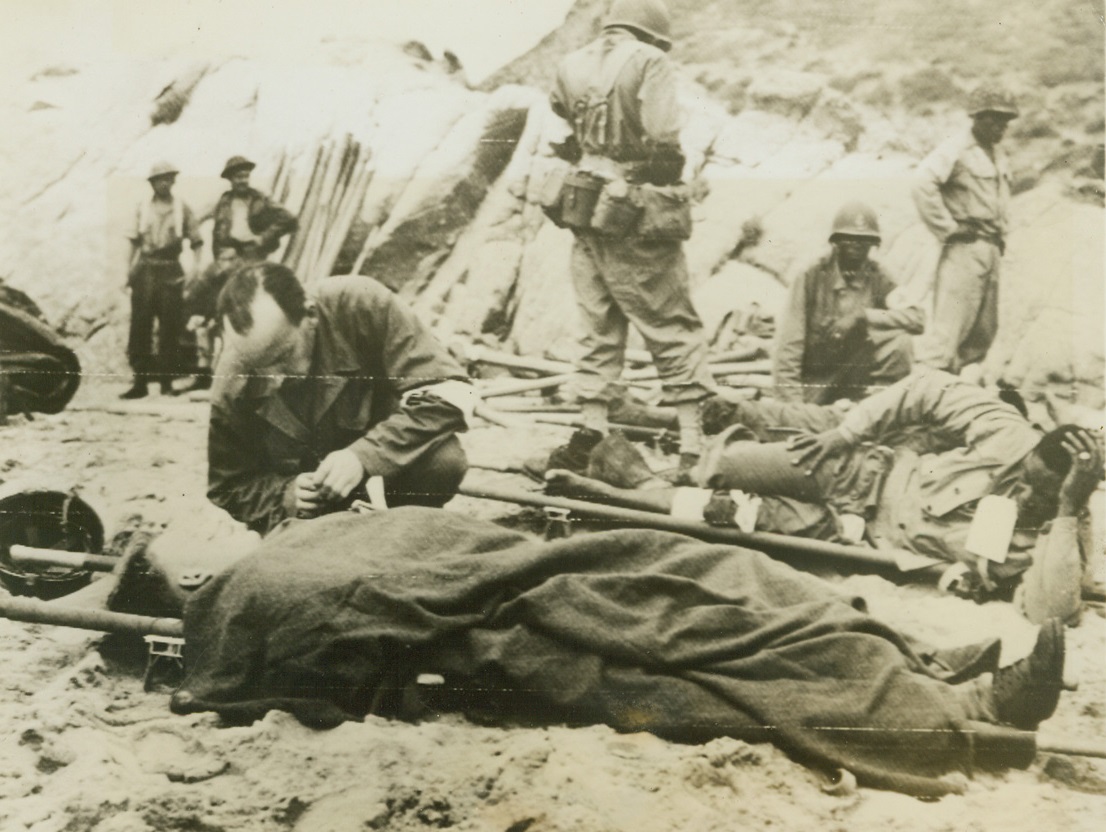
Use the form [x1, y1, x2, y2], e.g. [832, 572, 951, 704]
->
[914, 131, 1010, 242]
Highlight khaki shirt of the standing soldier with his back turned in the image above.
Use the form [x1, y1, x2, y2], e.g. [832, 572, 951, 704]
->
[550, 30, 681, 162]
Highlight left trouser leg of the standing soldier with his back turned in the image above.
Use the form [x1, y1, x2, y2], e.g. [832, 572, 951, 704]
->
[571, 235, 629, 410]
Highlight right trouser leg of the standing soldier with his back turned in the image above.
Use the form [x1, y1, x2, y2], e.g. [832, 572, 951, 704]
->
[588, 237, 714, 405]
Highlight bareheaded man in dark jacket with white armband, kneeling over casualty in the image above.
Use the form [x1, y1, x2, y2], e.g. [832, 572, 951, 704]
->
[208, 262, 477, 533]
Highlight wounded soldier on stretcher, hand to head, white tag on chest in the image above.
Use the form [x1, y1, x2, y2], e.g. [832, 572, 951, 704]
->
[546, 370, 1103, 624]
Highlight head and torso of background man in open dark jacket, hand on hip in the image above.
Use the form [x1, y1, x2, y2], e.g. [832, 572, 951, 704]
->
[211, 156, 298, 260]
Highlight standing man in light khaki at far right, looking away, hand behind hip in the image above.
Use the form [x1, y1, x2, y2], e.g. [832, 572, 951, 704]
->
[914, 86, 1018, 373]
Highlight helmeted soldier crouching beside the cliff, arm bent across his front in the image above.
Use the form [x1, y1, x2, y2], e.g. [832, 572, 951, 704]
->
[773, 202, 924, 404]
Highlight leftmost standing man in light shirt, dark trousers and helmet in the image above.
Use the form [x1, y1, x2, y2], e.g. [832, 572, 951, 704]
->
[121, 162, 204, 398]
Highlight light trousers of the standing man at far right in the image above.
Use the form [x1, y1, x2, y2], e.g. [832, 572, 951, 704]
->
[918, 240, 1001, 372]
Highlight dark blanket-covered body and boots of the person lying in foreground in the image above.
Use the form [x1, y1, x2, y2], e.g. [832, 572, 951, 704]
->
[155, 507, 1064, 795]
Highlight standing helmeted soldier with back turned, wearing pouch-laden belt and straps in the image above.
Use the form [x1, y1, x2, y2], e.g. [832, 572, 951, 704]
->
[543, 0, 713, 469]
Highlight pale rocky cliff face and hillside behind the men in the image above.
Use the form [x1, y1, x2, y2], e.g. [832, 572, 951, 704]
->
[0, 0, 1104, 407]
